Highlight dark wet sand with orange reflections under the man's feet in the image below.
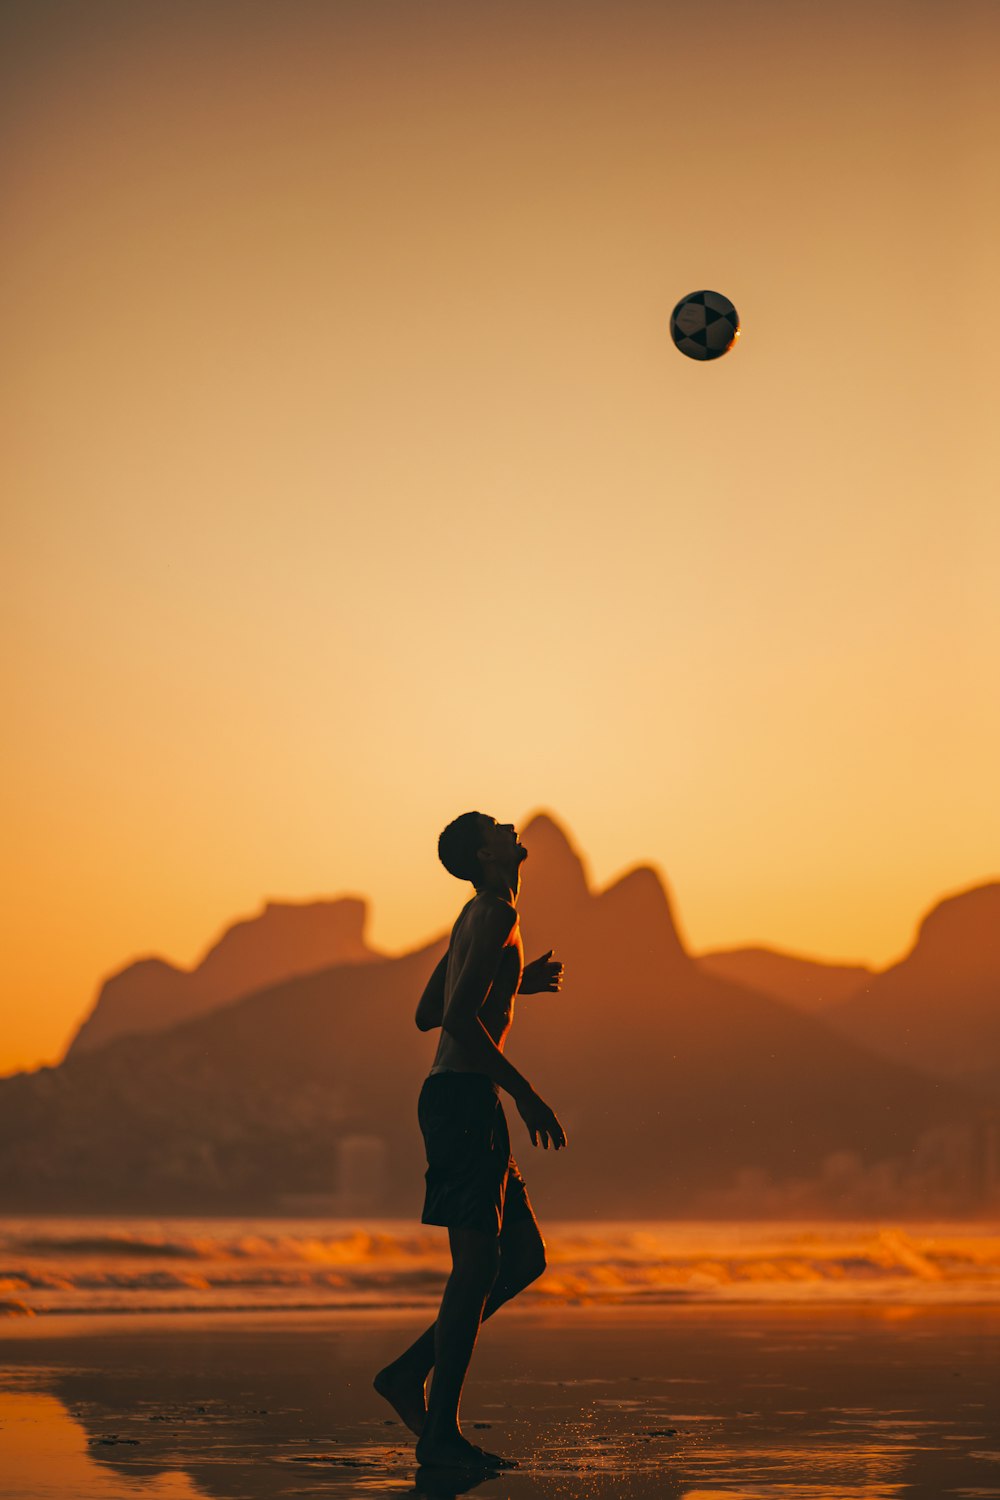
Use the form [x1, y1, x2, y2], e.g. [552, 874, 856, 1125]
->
[0, 1305, 1000, 1500]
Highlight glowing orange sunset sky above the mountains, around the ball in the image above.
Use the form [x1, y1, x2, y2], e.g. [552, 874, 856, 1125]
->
[0, 0, 1000, 1071]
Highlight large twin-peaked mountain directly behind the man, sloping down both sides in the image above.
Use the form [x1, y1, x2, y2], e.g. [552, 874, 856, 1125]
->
[0, 815, 982, 1220]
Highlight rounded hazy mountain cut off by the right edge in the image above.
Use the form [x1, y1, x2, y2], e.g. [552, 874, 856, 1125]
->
[825, 882, 1000, 1082]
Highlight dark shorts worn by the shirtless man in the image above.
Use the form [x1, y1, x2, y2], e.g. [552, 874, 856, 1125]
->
[417, 1073, 535, 1235]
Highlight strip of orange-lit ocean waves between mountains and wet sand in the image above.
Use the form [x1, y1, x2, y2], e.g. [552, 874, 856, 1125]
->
[0, 1218, 1000, 1317]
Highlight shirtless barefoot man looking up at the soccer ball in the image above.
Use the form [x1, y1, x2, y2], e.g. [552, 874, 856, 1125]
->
[373, 813, 567, 1467]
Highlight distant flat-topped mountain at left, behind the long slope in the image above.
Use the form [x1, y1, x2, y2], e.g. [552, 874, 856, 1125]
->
[66, 896, 378, 1056]
